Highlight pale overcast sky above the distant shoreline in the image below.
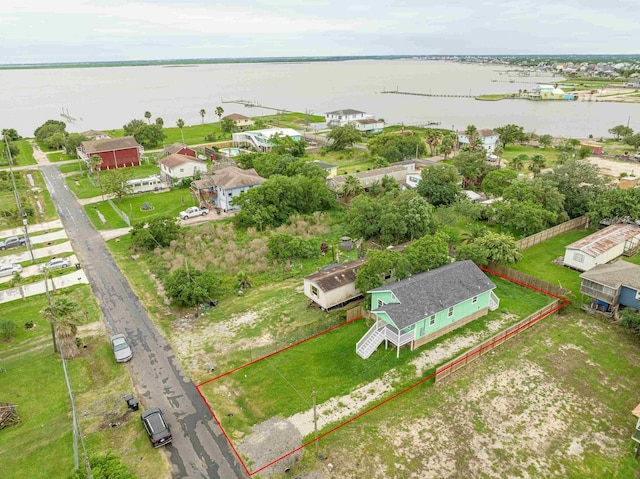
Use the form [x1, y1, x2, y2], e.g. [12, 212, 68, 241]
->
[0, 0, 640, 64]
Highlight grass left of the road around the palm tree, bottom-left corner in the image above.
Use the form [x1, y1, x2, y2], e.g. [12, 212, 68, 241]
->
[0, 286, 167, 479]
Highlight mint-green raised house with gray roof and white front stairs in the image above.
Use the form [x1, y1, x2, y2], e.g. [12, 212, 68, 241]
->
[356, 260, 500, 359]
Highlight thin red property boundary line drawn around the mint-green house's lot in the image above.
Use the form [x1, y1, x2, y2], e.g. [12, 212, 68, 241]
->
[196, 268, 570, 476]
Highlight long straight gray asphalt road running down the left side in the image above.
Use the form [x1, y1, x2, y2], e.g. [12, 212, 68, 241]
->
[40, 165, 248, 479]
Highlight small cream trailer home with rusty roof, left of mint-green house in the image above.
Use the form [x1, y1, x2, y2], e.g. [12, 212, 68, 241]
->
[304, 259, 364, 310]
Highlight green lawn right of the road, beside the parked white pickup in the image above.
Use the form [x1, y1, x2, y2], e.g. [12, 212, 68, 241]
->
[84, 188, 197, 230]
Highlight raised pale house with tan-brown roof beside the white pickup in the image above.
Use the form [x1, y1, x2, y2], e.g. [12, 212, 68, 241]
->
[191, 166, 266, 211]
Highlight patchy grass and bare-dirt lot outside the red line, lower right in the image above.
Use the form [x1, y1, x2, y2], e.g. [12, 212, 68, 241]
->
[294, 312, 640, 479]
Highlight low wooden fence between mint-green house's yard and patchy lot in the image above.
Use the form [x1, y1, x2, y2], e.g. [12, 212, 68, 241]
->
[434, 299, 565, 382]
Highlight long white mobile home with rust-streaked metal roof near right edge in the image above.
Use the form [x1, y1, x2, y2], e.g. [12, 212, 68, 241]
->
[564, 223, 640, 271]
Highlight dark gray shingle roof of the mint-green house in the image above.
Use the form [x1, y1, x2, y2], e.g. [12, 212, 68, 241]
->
[370, 260, 496, 329]
